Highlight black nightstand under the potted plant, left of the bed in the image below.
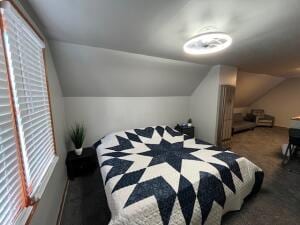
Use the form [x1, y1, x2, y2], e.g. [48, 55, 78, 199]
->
[66, 147, 99, 180]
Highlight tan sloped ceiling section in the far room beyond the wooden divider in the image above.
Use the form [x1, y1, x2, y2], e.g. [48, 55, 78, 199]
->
[234, 71, 285, 107]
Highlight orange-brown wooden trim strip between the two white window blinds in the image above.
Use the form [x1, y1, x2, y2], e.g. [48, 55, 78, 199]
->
[0, 9, 30, 207]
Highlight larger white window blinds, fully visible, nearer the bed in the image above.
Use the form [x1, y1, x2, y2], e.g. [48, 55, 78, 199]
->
[1, 4, 55, 197]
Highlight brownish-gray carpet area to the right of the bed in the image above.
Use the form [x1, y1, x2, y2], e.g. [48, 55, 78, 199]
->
[222, 127, 300, 225]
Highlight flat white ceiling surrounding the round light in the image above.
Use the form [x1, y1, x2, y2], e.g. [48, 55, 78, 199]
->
[28, 0, 300, 76]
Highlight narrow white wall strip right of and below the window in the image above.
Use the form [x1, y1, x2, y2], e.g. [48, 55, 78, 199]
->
[17, 2, 67, 225]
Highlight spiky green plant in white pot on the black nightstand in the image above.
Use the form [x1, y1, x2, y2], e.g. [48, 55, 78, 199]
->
[70, 123, 86, 155]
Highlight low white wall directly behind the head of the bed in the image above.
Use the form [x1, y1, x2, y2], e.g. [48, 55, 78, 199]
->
[65, 97, 189, 145]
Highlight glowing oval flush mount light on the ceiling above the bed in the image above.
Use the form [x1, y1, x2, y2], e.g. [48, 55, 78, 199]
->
[183, 32, 232, 55]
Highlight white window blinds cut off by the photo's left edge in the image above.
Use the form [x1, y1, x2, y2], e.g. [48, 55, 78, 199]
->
[0, 28, 24, 225]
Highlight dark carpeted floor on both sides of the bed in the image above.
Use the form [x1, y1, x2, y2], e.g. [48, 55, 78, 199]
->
[61, 127, 300, 225]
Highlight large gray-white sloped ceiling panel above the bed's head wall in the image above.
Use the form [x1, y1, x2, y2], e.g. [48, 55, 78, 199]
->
[50, 41, 210, 97]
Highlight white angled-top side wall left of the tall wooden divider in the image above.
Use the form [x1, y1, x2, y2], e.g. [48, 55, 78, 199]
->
[190, 66, 220, 143]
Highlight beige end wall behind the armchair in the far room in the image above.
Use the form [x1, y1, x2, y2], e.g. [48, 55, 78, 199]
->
[251, 78, 300, 127]
